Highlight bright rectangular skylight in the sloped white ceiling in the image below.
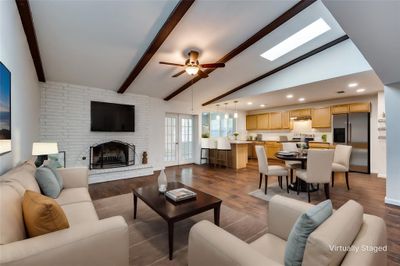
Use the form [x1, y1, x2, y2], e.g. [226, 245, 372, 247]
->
[261, 18, 331, 61]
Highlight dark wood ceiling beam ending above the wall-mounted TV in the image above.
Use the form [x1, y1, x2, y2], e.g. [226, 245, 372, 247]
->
[118, 0, 195, 93]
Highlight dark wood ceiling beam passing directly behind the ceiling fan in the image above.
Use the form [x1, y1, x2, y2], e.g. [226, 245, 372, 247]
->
[164, 0, 316, 101]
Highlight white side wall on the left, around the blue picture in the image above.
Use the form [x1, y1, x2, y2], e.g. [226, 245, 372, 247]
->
[0, 1, 40, 174]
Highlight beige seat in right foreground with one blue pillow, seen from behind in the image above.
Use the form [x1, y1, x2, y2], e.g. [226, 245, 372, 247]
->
[188, 196, 387, 266]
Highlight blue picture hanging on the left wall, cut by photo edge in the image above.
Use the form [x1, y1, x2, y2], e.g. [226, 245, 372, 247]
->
[0, 62, 11, 140]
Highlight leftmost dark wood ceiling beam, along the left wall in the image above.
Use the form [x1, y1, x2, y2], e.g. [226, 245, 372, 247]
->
[15, 0, 46, 82]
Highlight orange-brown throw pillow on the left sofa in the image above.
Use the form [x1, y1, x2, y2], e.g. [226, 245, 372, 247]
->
[22, 190, 69, 237]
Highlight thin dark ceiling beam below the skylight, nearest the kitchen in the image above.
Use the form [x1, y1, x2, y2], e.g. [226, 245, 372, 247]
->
[202, 35, 349, 106]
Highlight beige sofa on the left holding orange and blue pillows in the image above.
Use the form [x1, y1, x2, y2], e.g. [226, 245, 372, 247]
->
[0, 161, 129, 266]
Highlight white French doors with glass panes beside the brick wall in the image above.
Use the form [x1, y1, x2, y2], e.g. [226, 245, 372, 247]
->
[164, 114, 194, 166]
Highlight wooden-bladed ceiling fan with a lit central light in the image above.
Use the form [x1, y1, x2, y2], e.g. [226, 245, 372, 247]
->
[160, 50, 225, 78]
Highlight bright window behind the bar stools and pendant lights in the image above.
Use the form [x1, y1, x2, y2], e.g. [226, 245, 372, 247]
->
[201, 112, 236, 138]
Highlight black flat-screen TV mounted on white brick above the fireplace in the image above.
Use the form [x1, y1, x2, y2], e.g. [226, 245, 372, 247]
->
[90, 101, 135, 132]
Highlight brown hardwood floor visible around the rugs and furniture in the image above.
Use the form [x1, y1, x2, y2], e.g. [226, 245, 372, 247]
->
[89, 160, 400, 265]
